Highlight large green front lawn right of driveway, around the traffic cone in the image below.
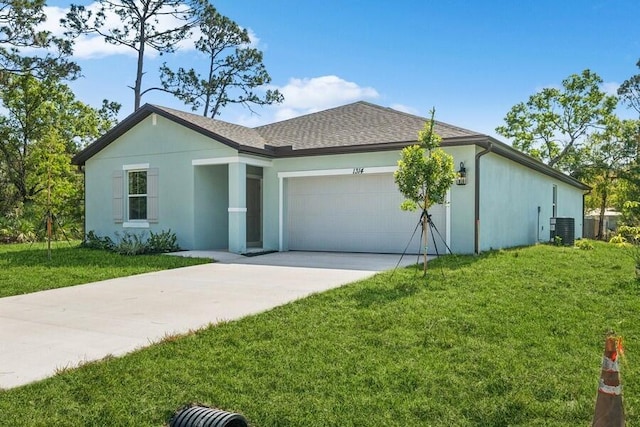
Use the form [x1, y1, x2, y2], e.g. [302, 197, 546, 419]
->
[0, 244, 640, 426]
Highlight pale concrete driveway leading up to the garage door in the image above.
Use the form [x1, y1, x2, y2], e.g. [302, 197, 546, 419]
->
[0, 252, 416, 388]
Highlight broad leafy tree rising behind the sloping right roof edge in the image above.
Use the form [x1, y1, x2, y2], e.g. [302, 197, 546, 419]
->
[496, 70, 618, 174]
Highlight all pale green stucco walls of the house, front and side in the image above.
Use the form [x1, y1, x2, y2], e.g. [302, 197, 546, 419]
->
[85, 115, 582, 253]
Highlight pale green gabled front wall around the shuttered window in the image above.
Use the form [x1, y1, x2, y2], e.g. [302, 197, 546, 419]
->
[85, 115, 237, 248]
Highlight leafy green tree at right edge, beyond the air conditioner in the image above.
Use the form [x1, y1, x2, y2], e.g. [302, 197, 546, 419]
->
[576, 117, 640, 239]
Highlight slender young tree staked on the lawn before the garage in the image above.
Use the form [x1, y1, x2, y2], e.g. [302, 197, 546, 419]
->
[394, 109, 456, 274]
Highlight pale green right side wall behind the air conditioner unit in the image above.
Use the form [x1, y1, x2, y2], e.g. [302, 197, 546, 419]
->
[479, 149, 583, 251]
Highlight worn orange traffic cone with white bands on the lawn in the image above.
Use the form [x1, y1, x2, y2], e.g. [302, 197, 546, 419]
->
[592, 336, 624, 427]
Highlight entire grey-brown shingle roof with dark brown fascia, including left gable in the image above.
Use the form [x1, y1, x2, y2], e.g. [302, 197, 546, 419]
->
[72, 101, 486, 165]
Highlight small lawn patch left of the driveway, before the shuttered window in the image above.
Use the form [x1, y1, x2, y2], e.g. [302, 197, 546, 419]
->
[0, 242, 210, 298]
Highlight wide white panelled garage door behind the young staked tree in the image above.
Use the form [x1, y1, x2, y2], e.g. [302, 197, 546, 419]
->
[286, 173, 446, 254]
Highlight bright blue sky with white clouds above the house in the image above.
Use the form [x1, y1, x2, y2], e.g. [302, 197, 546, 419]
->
[42, 0, 640, 136]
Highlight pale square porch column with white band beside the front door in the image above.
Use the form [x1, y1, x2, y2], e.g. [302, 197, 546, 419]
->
[229, 162, 247, 254]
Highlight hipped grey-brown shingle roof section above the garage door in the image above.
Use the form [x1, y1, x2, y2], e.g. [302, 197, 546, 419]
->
[255, 101, 480, 150]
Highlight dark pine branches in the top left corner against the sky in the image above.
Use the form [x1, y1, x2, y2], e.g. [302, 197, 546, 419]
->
[0, 0, 80, 79]
